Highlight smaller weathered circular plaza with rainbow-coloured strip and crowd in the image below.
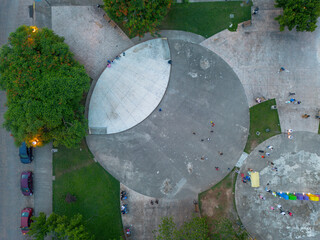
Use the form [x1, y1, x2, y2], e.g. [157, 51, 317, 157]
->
[236, 132, 320, 240]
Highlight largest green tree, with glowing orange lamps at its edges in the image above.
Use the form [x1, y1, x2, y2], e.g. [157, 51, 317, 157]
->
[0, 26, 90, 147]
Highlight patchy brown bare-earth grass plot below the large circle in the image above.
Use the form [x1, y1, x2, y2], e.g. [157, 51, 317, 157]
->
[199, 169, 247, 239]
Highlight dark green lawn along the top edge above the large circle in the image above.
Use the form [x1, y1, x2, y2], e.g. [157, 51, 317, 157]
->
[160, 1, 252, 38]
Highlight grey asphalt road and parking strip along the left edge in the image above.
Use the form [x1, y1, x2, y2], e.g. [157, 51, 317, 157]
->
[0, 0, 52, 240]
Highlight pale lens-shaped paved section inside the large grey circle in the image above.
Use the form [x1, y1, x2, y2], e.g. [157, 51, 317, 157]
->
[89, 39, 171, 134]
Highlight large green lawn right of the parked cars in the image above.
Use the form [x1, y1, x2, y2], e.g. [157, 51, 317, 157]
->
[53, 141, 123, 240]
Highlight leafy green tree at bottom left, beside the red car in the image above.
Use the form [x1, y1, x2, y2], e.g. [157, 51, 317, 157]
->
[28, 212, 94, 240]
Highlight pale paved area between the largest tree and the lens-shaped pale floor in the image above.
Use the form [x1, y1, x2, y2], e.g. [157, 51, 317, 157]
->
[51, 6, 133, 80]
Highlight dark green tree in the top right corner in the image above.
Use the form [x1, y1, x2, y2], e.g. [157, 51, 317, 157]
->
[275, 0, 320, 32]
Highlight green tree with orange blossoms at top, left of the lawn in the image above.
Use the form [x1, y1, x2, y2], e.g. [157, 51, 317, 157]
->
[104, 0, 173, 37]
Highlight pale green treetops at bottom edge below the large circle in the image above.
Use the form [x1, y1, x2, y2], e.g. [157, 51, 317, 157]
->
[153, 217, 209, 240]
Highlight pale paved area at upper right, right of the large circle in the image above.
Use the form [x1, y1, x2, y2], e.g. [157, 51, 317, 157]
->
[201, 8, 320, 132]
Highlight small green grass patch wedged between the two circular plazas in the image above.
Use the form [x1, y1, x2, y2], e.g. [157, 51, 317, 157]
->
[244, 99, 281, 153]
